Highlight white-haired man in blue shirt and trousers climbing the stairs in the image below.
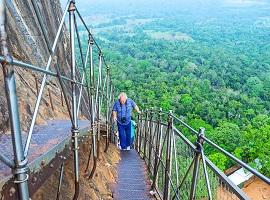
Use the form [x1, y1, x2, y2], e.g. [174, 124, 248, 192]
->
[113, 92, 141, 150]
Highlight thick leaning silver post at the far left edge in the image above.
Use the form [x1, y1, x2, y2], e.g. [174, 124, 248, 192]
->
[0, 0, 29, 200]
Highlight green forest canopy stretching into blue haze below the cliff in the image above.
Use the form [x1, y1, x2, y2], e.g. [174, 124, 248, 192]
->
[76, 1, 270, 176]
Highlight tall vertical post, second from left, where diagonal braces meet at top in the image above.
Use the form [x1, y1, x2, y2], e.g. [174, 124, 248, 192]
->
[68, 1, 80, 200]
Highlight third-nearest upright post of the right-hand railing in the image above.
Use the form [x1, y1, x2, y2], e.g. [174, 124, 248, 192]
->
[151, 108, 162, 192]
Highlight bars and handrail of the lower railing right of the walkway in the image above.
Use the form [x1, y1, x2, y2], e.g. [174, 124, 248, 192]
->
[135, 109, 270, 200]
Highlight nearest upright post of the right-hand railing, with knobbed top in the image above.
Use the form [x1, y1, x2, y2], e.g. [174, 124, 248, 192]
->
[189, 128, 204, 200]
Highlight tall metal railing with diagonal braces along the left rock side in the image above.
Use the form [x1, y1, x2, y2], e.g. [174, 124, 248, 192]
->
[0, 0, 114, 200]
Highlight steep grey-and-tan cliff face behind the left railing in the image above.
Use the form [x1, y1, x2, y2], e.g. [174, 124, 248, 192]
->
[0, 0, 76, 132]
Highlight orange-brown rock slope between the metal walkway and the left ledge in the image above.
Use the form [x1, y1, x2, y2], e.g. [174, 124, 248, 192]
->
[32, 140, 120, 200]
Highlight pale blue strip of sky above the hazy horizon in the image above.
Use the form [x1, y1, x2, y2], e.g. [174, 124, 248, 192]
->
[60, 0, 270, 16]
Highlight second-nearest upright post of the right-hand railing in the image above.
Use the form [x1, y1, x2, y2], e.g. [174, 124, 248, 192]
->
[163, 110, 173, 200]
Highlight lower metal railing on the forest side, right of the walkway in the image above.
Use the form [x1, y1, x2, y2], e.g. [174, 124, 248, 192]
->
[135, 109, 270, 200]
